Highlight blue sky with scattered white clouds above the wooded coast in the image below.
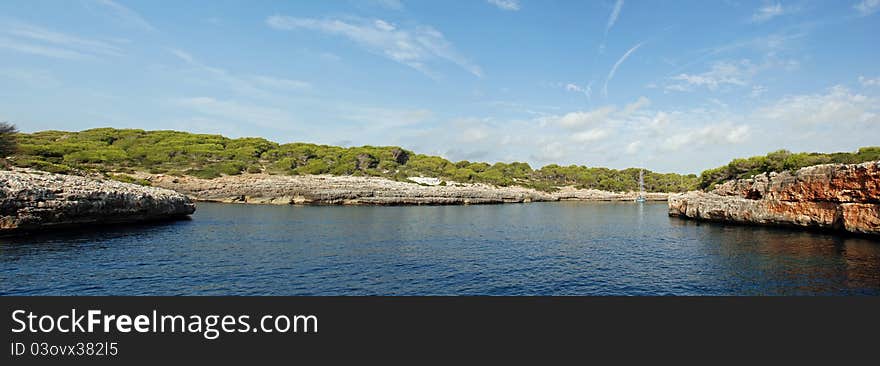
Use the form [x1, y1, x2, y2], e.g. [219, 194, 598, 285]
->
[0, 0, 880, 173]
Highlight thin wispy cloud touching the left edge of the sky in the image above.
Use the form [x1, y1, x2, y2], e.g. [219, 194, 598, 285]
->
[0, 22, 122, 60]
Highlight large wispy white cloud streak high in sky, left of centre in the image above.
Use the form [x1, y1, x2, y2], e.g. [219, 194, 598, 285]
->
[266, 15, 483, 77]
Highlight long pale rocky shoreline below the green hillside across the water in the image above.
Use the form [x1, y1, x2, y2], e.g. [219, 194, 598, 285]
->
[138, 174, 666, 205]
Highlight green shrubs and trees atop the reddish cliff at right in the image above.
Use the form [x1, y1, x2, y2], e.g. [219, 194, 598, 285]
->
[700, 146, 880, 189]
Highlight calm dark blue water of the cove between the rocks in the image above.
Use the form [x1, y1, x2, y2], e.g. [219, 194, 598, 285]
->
[0, 202, 880, 295]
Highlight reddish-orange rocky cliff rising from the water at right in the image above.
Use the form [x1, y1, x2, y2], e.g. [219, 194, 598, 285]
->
[669, 161, 880, 235]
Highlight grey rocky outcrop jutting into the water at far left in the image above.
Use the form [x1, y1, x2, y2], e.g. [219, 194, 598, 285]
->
[0, 169, 195, 234]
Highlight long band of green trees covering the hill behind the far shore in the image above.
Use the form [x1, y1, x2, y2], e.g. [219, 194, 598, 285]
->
[11, 128, 699, 192]
